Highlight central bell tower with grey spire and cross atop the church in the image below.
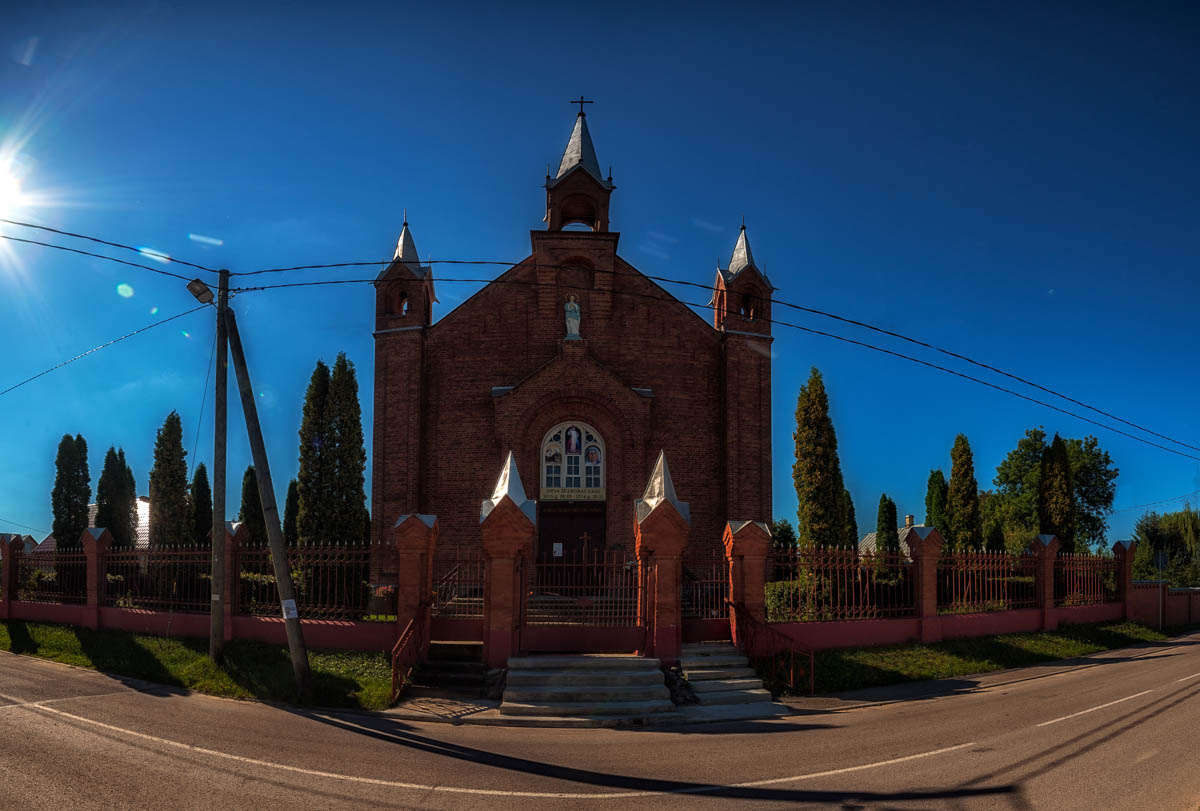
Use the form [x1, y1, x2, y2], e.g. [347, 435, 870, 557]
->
[545, 96, 616, 233]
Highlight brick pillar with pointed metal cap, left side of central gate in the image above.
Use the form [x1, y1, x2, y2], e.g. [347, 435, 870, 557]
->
[479, 451, 538, 667]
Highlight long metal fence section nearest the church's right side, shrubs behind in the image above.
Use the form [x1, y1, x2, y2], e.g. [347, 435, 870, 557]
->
[766, 549, 917, 623]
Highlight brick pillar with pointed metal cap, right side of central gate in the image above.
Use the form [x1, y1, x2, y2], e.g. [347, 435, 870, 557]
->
[634, 451, 690, 666]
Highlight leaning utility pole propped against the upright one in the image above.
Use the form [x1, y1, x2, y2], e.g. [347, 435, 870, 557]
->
[222, 307, 310, 698]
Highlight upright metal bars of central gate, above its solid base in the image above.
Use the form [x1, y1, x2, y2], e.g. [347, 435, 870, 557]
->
[524, 549, 638, 627]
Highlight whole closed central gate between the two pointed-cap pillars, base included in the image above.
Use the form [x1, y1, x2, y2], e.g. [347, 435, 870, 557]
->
[521, 548, 653, 653]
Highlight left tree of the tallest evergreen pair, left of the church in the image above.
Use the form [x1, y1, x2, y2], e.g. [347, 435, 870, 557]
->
[296, 360, 335, 546]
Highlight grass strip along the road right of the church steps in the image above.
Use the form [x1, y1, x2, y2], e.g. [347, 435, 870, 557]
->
[761, 621, 1182, 695]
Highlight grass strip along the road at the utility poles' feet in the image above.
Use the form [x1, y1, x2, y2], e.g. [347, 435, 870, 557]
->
[0, 620, 391, 709]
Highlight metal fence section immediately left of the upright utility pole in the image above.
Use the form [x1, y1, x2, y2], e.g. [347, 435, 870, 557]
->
[101, 546, 212, 613]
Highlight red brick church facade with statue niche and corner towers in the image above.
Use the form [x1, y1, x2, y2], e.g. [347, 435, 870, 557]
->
[372, 116, 772, 566]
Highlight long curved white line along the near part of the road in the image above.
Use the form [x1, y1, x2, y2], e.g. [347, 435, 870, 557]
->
[0, 693, 976, 800]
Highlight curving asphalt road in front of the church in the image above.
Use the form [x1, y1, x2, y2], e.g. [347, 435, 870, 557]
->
[0, 633, 1200, 811]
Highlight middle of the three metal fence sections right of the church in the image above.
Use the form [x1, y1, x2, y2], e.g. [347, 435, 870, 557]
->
[937, 552, 1038, 614]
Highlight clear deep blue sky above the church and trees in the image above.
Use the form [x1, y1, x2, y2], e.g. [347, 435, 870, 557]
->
[0, 2, 1200, 539]
